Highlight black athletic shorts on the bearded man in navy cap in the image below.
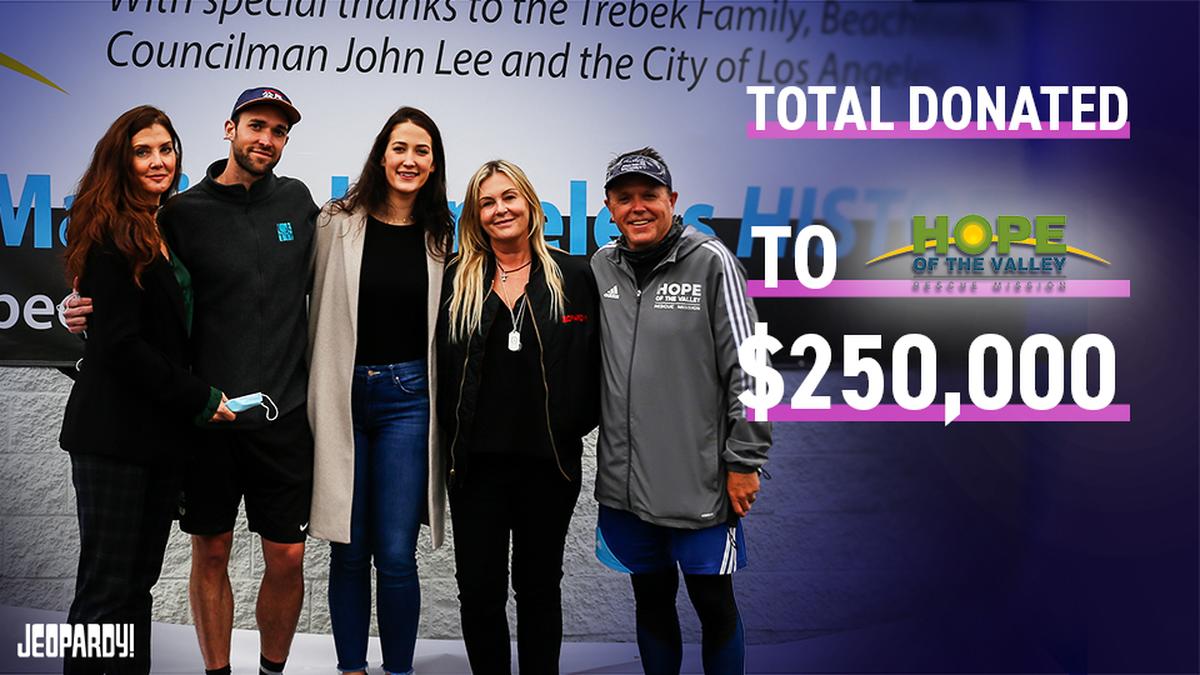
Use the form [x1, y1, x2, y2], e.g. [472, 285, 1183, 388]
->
[179, 406, 312, 544]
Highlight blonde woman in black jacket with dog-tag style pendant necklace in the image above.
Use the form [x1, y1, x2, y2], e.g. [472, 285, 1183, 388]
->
[438, 160, 600, 675]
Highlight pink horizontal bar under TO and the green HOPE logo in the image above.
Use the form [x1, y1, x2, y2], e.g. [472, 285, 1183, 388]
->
[746, 277, 1129, 298]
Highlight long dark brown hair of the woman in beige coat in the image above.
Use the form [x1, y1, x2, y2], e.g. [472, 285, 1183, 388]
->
[334, 106, 454, 259]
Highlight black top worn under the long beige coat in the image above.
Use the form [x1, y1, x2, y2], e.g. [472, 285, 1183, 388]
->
[354, 216, 430, 365]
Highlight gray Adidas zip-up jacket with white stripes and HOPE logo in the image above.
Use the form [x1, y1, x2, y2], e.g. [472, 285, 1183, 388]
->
[592, 227, 770, 530]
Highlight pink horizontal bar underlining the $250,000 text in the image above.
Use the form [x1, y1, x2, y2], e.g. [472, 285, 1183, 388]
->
[767, 404, 1129, 424]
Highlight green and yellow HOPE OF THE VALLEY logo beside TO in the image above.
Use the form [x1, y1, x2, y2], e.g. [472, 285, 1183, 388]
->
[866, 214, 1111, 293]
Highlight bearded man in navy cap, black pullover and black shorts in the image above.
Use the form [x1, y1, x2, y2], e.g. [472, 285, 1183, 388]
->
[67, 86, 317, 675]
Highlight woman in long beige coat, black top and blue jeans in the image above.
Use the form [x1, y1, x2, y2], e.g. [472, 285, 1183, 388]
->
[308, 107, 454, 673]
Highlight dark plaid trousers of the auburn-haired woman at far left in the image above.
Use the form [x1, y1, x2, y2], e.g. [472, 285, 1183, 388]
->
[62, 454, 180, 675]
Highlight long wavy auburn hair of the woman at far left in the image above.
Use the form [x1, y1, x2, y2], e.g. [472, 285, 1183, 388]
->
[66, 106, 184, 287]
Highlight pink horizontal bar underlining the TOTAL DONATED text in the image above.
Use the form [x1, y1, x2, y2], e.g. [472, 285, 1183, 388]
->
[746, 120, 1129, 141]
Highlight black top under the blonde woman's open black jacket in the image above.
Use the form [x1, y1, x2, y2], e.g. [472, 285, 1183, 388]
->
[467, 293, 553, 461]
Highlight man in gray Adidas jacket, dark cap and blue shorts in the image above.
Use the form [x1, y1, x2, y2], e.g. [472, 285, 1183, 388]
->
[592, 148, 770, 674]
